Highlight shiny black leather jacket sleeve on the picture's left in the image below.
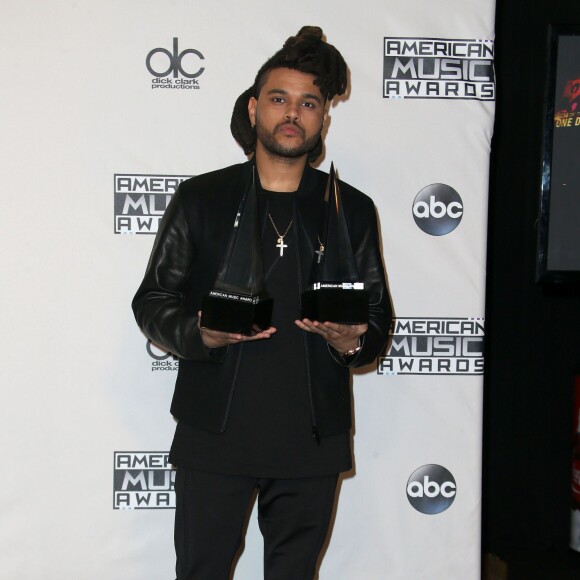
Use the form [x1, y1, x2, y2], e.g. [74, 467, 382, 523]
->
[132, 187, 227, 362]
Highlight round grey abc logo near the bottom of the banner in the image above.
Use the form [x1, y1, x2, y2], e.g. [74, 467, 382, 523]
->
[407, 464, 457, 514]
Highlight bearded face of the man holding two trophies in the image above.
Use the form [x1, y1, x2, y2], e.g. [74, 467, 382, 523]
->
[248, 68, 326, 159]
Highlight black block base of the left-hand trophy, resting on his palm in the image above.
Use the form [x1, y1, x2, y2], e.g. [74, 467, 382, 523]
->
[200, 290, 274, 336]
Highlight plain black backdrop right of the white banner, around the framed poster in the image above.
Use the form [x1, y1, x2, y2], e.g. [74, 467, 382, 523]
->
[482, 0, 580, 556]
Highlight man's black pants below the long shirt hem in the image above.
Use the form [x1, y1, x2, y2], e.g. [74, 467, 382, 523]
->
[175, 468, 338, 580]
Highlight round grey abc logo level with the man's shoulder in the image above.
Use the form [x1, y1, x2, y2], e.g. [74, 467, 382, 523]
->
[413, 183, 463, 236]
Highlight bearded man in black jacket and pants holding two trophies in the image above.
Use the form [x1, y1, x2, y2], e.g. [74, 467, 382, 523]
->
[133, 27, 391, 580]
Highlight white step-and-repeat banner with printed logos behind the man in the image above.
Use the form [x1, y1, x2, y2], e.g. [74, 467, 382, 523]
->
[0, 0, 495, 580]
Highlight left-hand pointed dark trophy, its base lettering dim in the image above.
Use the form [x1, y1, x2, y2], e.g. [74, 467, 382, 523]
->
[200, 168, 273, 336]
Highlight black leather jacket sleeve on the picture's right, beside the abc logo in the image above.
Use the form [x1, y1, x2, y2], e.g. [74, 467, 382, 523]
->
[329, 202, 393, 367]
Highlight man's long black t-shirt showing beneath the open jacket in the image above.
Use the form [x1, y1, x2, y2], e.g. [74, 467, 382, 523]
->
[170, 191, 352, 478]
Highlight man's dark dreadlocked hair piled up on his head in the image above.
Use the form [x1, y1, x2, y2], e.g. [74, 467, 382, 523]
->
[230, 26, 347, 161]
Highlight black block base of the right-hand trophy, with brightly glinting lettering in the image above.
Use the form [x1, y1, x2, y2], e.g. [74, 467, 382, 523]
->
[301, 282, 369, 324]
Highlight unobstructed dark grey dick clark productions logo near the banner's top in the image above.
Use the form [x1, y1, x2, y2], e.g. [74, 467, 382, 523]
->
[145, 38, 205, 89]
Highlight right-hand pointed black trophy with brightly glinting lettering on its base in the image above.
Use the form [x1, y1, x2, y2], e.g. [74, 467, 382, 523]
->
[301, 164, 369, 324]
